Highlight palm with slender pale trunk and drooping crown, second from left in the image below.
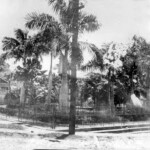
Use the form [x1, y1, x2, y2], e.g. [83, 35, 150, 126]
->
[26, 13, 61, 104]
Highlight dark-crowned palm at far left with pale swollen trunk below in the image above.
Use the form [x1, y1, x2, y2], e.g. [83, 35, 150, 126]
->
[2, 29, 46, 104]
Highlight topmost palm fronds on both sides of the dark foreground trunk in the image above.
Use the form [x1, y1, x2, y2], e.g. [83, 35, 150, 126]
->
[48, 0, 100, 33]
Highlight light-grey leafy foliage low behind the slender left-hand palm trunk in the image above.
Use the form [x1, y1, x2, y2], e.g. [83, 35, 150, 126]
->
[27, 71, 60, 105]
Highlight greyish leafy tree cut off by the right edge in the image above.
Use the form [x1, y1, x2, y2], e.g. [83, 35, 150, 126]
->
[131, 36, 150, 101]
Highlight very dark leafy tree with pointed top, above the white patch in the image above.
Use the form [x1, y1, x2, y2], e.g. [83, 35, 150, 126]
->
[116, 44, 140, 99]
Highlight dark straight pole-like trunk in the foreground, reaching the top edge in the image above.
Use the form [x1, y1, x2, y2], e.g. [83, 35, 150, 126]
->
[69, 0, 79, 134]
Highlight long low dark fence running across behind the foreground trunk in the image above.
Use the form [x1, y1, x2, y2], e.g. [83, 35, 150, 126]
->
[0, 105, 150, 128]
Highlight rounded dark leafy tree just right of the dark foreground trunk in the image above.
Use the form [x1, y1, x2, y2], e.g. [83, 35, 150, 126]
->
[80, 73, 108, 109]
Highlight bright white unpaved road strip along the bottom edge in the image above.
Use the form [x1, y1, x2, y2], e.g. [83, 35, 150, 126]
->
[0, 134, 150, 150]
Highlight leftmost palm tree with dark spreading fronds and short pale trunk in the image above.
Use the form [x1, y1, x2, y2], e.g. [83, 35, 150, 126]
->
[2, 29, 32, 104]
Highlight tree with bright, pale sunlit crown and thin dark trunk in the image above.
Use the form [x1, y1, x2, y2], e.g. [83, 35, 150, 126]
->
[81, 43, 126, 114]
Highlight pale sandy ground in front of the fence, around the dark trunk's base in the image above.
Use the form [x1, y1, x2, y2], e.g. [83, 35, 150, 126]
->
[0, 117, 150, 150]
